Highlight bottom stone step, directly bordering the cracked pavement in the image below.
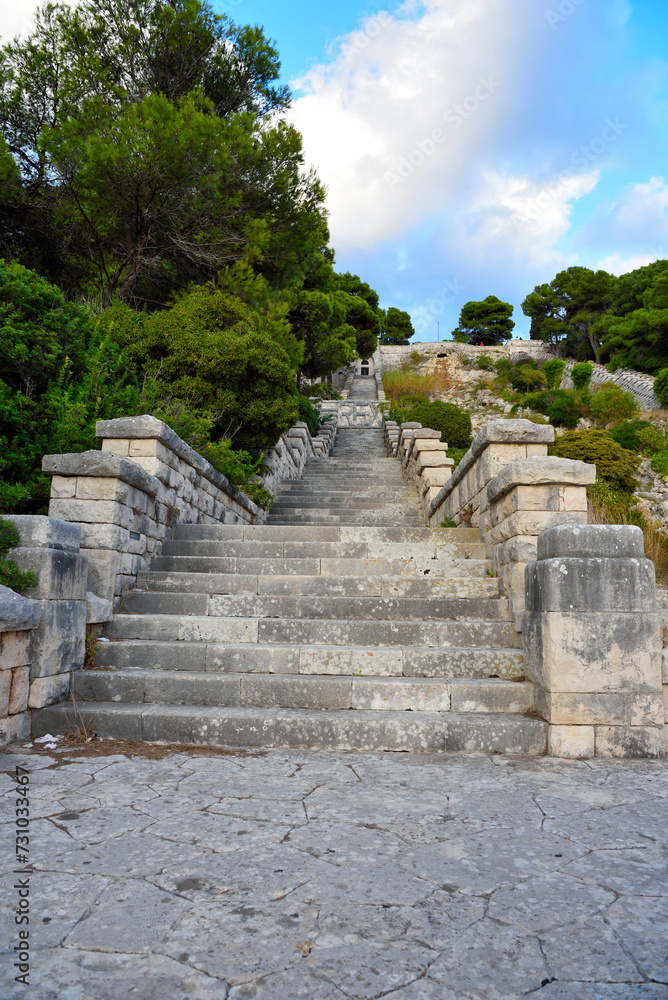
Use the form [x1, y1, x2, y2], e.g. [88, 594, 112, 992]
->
[33, 702, 547, 755]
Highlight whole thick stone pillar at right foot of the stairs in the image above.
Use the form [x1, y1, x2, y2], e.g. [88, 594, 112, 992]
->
[523, 524, 665, 757]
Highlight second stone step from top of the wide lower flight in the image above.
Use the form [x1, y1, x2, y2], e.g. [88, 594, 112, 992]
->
[162, 538, 486, 562]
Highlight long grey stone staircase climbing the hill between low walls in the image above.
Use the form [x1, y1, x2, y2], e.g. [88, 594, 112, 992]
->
[36, 420, 546, 754]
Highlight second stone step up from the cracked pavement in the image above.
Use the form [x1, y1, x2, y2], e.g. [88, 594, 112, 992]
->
[74, 670, 533, 713]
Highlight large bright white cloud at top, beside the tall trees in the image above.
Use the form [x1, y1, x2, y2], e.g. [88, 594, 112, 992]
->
[291, 0, 535, 252]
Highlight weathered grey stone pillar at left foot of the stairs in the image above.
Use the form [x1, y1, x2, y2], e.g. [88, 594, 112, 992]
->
[9, 515, 88, 708]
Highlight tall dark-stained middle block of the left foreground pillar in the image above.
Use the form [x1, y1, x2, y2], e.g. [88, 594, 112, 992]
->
[30, 601, 86, 680]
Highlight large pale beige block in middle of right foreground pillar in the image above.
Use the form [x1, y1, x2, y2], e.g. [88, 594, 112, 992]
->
[522, 611, 661, 694]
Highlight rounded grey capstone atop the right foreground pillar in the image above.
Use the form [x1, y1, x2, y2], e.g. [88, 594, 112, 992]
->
[537, 524, 645, 561]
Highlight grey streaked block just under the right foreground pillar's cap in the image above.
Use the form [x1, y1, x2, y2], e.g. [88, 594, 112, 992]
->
[525, 560, 656, 614]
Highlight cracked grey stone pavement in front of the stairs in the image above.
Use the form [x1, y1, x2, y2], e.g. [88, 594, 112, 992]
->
[0, 747, 668, 1000]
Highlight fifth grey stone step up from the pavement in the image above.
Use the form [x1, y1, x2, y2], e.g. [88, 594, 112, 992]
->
[122, 590, 508, 622]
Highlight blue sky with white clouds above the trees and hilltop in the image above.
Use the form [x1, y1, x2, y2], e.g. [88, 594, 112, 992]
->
[0, 0, 668, 340]
